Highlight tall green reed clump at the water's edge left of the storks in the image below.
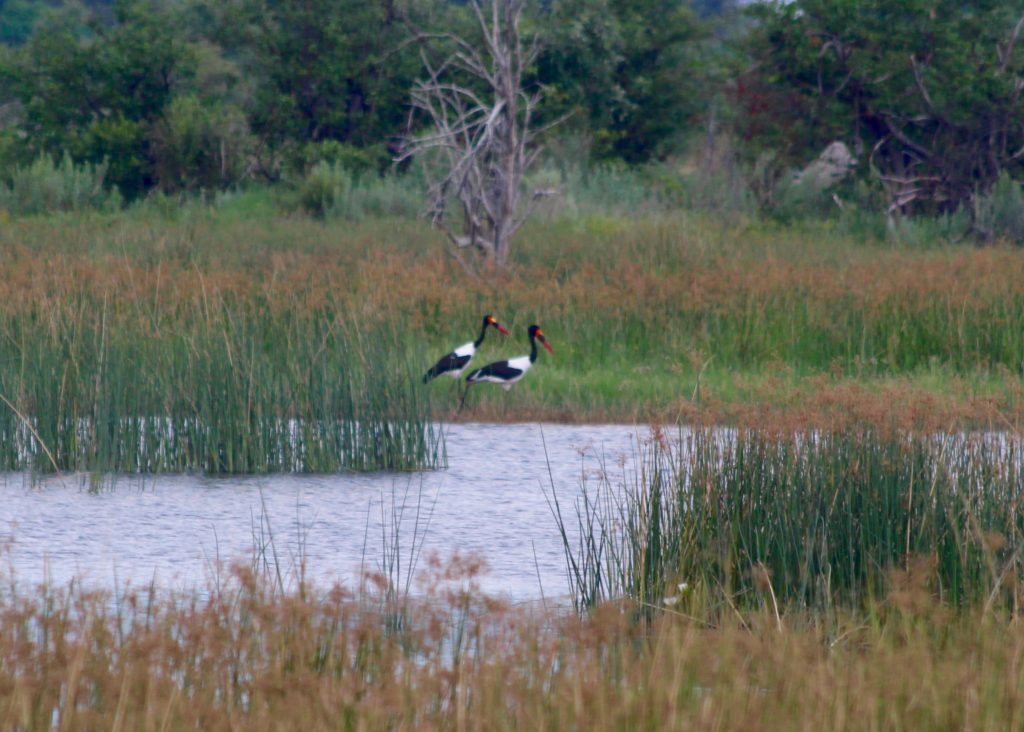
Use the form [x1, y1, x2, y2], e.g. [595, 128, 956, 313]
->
[0, 265, 439, 473]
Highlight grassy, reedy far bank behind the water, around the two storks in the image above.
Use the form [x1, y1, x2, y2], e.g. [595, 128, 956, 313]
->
[0, 196, 1024, 472]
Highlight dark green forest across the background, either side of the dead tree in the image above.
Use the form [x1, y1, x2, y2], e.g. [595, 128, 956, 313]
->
[0, 0, 1024, 237]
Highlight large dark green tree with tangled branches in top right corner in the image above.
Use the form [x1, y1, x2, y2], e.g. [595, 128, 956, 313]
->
[736, 0, 1024, 219]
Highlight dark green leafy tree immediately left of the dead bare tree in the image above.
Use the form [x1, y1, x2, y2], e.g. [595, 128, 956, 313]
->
[207, 0, 419, 174]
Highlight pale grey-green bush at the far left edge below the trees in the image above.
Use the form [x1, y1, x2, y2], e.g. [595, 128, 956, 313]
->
[0, 155, 121, 215]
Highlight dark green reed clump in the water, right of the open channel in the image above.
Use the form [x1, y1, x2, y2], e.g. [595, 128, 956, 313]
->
[559, 427, 1024, 612]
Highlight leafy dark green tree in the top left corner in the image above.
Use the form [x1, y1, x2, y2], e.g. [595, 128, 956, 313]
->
[0, 1, 195, 198]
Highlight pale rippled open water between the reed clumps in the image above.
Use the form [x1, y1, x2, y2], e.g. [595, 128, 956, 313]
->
[0, 424, 647, 599]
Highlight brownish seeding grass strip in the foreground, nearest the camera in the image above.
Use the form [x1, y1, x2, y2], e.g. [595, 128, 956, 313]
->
[0, 560, 1024, 730]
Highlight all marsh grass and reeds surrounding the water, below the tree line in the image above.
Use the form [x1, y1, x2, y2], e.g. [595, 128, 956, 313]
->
[0, 193, 1024, 729]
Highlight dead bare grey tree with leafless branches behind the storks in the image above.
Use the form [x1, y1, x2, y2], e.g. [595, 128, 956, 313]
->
[398, 0, 554, 274]
